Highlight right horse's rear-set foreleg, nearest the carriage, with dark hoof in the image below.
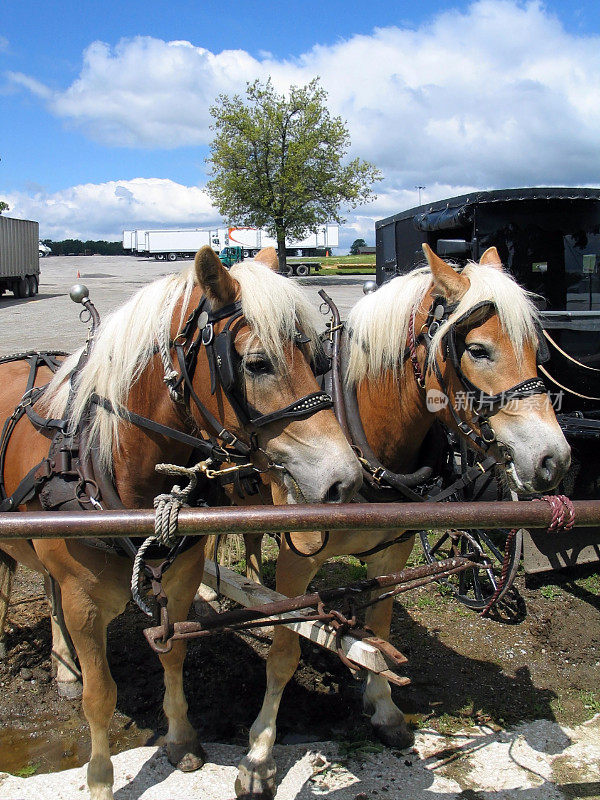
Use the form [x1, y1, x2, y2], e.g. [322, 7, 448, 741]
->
[363, 539, 415, 749]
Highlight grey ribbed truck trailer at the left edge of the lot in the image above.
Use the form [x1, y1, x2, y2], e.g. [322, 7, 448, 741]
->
[0, 216, 40, 297]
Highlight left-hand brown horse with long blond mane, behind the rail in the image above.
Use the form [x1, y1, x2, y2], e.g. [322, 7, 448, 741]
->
[0, 248, 360, 800]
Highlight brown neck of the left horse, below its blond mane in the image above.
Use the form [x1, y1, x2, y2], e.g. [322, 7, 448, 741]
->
[113, 355, 191, 508]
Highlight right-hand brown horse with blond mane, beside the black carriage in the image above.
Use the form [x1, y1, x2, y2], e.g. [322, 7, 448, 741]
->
[236, 245, 570, 798]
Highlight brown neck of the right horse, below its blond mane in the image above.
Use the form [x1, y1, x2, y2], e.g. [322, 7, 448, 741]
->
[356, 364, 433, 473]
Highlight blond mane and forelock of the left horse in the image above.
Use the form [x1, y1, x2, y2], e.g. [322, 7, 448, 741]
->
[40, 261, 318, 471]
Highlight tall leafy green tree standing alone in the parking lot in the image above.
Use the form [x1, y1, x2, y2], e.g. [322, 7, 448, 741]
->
[207, 78, 381, 271]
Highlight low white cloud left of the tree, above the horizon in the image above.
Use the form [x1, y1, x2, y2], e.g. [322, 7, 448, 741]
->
[3, 178, 219, 241]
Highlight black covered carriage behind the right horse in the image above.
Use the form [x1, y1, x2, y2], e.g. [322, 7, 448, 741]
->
[375, 188, 600, 573]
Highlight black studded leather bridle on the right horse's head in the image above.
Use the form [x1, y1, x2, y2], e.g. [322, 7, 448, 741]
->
[407, 297, 549, 451]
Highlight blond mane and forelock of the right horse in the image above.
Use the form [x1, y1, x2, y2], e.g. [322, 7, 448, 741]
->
[345, 261, 538, 384]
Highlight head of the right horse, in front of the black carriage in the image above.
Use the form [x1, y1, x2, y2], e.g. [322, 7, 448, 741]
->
[422, 245, 570, 494]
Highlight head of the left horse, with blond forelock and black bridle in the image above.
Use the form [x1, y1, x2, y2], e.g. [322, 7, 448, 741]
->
[192, 247, 361, 502]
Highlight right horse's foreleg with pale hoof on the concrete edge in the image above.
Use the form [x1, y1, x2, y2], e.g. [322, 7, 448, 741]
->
[235, 544, 322, 800]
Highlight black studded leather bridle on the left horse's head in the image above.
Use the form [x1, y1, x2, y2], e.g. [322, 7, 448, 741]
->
[169, 296, 333, 450]
